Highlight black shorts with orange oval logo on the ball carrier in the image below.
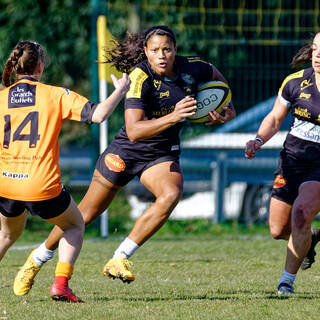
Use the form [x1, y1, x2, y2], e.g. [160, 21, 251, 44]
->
[96, 143, 179, 186]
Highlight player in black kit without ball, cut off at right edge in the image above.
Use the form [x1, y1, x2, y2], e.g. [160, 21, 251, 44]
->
[245, 33, 320, 294]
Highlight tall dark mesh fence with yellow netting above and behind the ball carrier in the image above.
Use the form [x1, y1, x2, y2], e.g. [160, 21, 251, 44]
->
[107, 0, 320, 112]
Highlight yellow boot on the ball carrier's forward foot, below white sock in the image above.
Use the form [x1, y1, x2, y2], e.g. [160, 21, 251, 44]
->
[103, 258, 134, 283]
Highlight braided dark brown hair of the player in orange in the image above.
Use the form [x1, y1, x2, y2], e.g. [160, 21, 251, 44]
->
[2, 40, 45, 87]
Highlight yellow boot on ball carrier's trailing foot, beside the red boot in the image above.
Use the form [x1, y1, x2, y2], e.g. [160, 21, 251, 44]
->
[13, 249, 41, 296]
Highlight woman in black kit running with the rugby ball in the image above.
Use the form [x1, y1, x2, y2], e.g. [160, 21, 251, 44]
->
[15, 26, 235, 287]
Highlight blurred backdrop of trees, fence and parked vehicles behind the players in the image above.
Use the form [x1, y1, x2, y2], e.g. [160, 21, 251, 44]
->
[0, 0, 320, 233]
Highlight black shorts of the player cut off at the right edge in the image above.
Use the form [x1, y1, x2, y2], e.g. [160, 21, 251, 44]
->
[271, 151, 320, 205]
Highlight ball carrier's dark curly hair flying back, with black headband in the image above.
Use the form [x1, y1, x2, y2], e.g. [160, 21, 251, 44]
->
[103, 26, 176, 73]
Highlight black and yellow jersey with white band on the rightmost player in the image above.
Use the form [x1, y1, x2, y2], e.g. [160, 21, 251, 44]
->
[278, 68, 320, 163]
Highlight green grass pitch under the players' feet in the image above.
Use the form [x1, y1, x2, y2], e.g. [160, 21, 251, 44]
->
[0, 234, 320, 320]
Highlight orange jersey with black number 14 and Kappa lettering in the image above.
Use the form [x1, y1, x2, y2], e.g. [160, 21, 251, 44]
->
[0, 77, 96, 201]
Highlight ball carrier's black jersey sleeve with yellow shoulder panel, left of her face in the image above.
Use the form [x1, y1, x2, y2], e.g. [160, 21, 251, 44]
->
[125, 68, 149, 109]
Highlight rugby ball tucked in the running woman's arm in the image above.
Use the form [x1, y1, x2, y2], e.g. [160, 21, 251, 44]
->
[188, 81, 231, 122]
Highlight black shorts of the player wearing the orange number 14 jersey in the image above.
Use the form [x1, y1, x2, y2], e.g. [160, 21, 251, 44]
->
[0, 187, 71, 219]
